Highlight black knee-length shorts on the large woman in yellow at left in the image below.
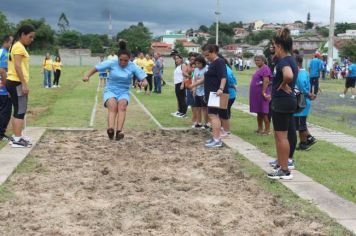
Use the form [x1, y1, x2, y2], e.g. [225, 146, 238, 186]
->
[6, 80, 28, 120]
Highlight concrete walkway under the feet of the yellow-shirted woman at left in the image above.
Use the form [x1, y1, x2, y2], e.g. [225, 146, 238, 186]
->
[0, 128, 46, 186]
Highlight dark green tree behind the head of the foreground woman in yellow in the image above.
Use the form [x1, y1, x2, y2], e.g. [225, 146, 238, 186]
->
[16, 18, 55, 51]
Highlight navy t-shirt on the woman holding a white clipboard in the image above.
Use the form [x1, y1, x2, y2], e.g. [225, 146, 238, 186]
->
[204, 58, 227, 101]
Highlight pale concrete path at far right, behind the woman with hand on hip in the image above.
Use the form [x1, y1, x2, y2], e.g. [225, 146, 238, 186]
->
[233, 103, 356, 153]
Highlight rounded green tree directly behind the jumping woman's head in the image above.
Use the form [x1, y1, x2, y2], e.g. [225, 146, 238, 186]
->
[117, 22, 152, 53]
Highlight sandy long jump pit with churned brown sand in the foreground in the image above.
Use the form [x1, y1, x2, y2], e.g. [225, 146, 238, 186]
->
[0, 131, 334, 236]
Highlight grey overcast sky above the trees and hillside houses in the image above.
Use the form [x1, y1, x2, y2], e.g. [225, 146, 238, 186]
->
[0, 0, 356, 35]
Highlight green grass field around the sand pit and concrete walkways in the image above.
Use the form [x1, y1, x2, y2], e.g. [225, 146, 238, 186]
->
[0, 67, 356, 235]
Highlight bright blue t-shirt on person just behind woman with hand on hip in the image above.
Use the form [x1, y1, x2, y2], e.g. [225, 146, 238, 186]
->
[294, 69, 311, 116]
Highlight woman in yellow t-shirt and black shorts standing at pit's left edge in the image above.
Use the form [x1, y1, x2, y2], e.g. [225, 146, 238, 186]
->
[6, 25, 35, 147]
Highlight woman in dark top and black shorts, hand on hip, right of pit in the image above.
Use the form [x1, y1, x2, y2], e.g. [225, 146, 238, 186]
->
[268, 28, 298, 179]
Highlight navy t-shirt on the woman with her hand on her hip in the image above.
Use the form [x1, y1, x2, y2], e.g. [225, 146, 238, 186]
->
[272, 56, 298, 98]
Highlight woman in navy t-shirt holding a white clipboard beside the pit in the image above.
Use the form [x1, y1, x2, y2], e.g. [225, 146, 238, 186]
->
[203, 44, 227, 148]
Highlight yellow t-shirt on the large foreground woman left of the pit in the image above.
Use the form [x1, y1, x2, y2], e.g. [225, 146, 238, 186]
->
[6, 42, 30, 82]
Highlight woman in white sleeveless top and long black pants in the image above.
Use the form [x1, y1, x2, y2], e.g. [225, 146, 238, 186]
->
[172, 55, 187, 118]
